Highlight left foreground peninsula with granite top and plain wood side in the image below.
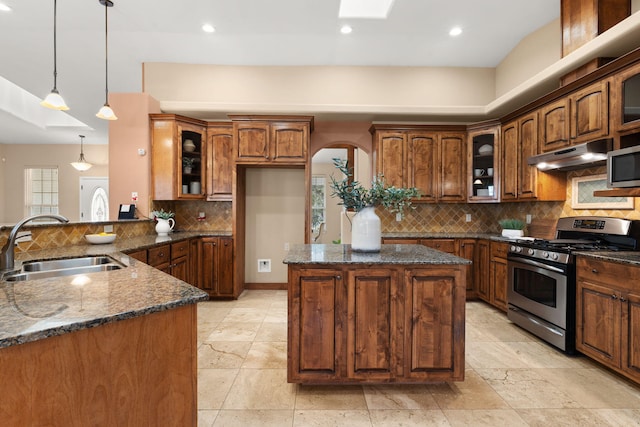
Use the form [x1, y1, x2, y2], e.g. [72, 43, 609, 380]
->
[0, 252, 207, 426]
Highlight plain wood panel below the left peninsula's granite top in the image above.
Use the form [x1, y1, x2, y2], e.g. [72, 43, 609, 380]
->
[0, 304, 197, 427]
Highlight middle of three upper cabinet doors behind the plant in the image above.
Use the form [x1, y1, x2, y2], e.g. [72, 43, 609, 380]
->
[408, 133, 438, 201]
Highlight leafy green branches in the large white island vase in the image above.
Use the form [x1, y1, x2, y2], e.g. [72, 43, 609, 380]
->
[331, 159, 420, 217]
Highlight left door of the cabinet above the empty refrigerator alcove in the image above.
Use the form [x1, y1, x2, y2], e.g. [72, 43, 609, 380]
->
[233, 122, 270, 163]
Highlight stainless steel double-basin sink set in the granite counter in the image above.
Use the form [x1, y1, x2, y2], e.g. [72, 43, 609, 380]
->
[3, 255, 125, 282]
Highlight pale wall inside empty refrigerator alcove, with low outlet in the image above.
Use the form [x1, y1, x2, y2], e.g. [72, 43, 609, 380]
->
[245, 168, 306, 283]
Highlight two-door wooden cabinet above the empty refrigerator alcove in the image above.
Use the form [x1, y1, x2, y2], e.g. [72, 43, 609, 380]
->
[229, 115, 313, 165]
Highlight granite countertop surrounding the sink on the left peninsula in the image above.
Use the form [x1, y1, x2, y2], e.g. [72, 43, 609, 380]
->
[0, 231, 231, 348]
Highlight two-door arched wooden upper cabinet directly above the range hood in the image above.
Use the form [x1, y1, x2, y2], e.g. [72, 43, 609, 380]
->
[539, 80, 609, 153]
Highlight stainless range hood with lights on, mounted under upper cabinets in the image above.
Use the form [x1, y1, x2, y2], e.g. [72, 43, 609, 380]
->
[527, 138, 613, 171]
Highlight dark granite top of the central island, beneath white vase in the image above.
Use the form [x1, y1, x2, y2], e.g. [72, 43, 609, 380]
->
[283, 244, 471, 265]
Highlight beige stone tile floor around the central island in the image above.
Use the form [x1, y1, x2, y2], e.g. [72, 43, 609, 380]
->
[198, 291, 640, 427]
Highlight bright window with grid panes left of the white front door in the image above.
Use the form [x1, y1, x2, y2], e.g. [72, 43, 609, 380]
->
[24, 166, 58, 216]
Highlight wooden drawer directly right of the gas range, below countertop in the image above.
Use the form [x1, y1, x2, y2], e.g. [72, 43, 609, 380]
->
[576, 256, 640, 290]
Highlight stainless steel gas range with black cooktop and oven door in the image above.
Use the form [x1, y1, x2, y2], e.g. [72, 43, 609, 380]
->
[507, 216, 640, 354]
